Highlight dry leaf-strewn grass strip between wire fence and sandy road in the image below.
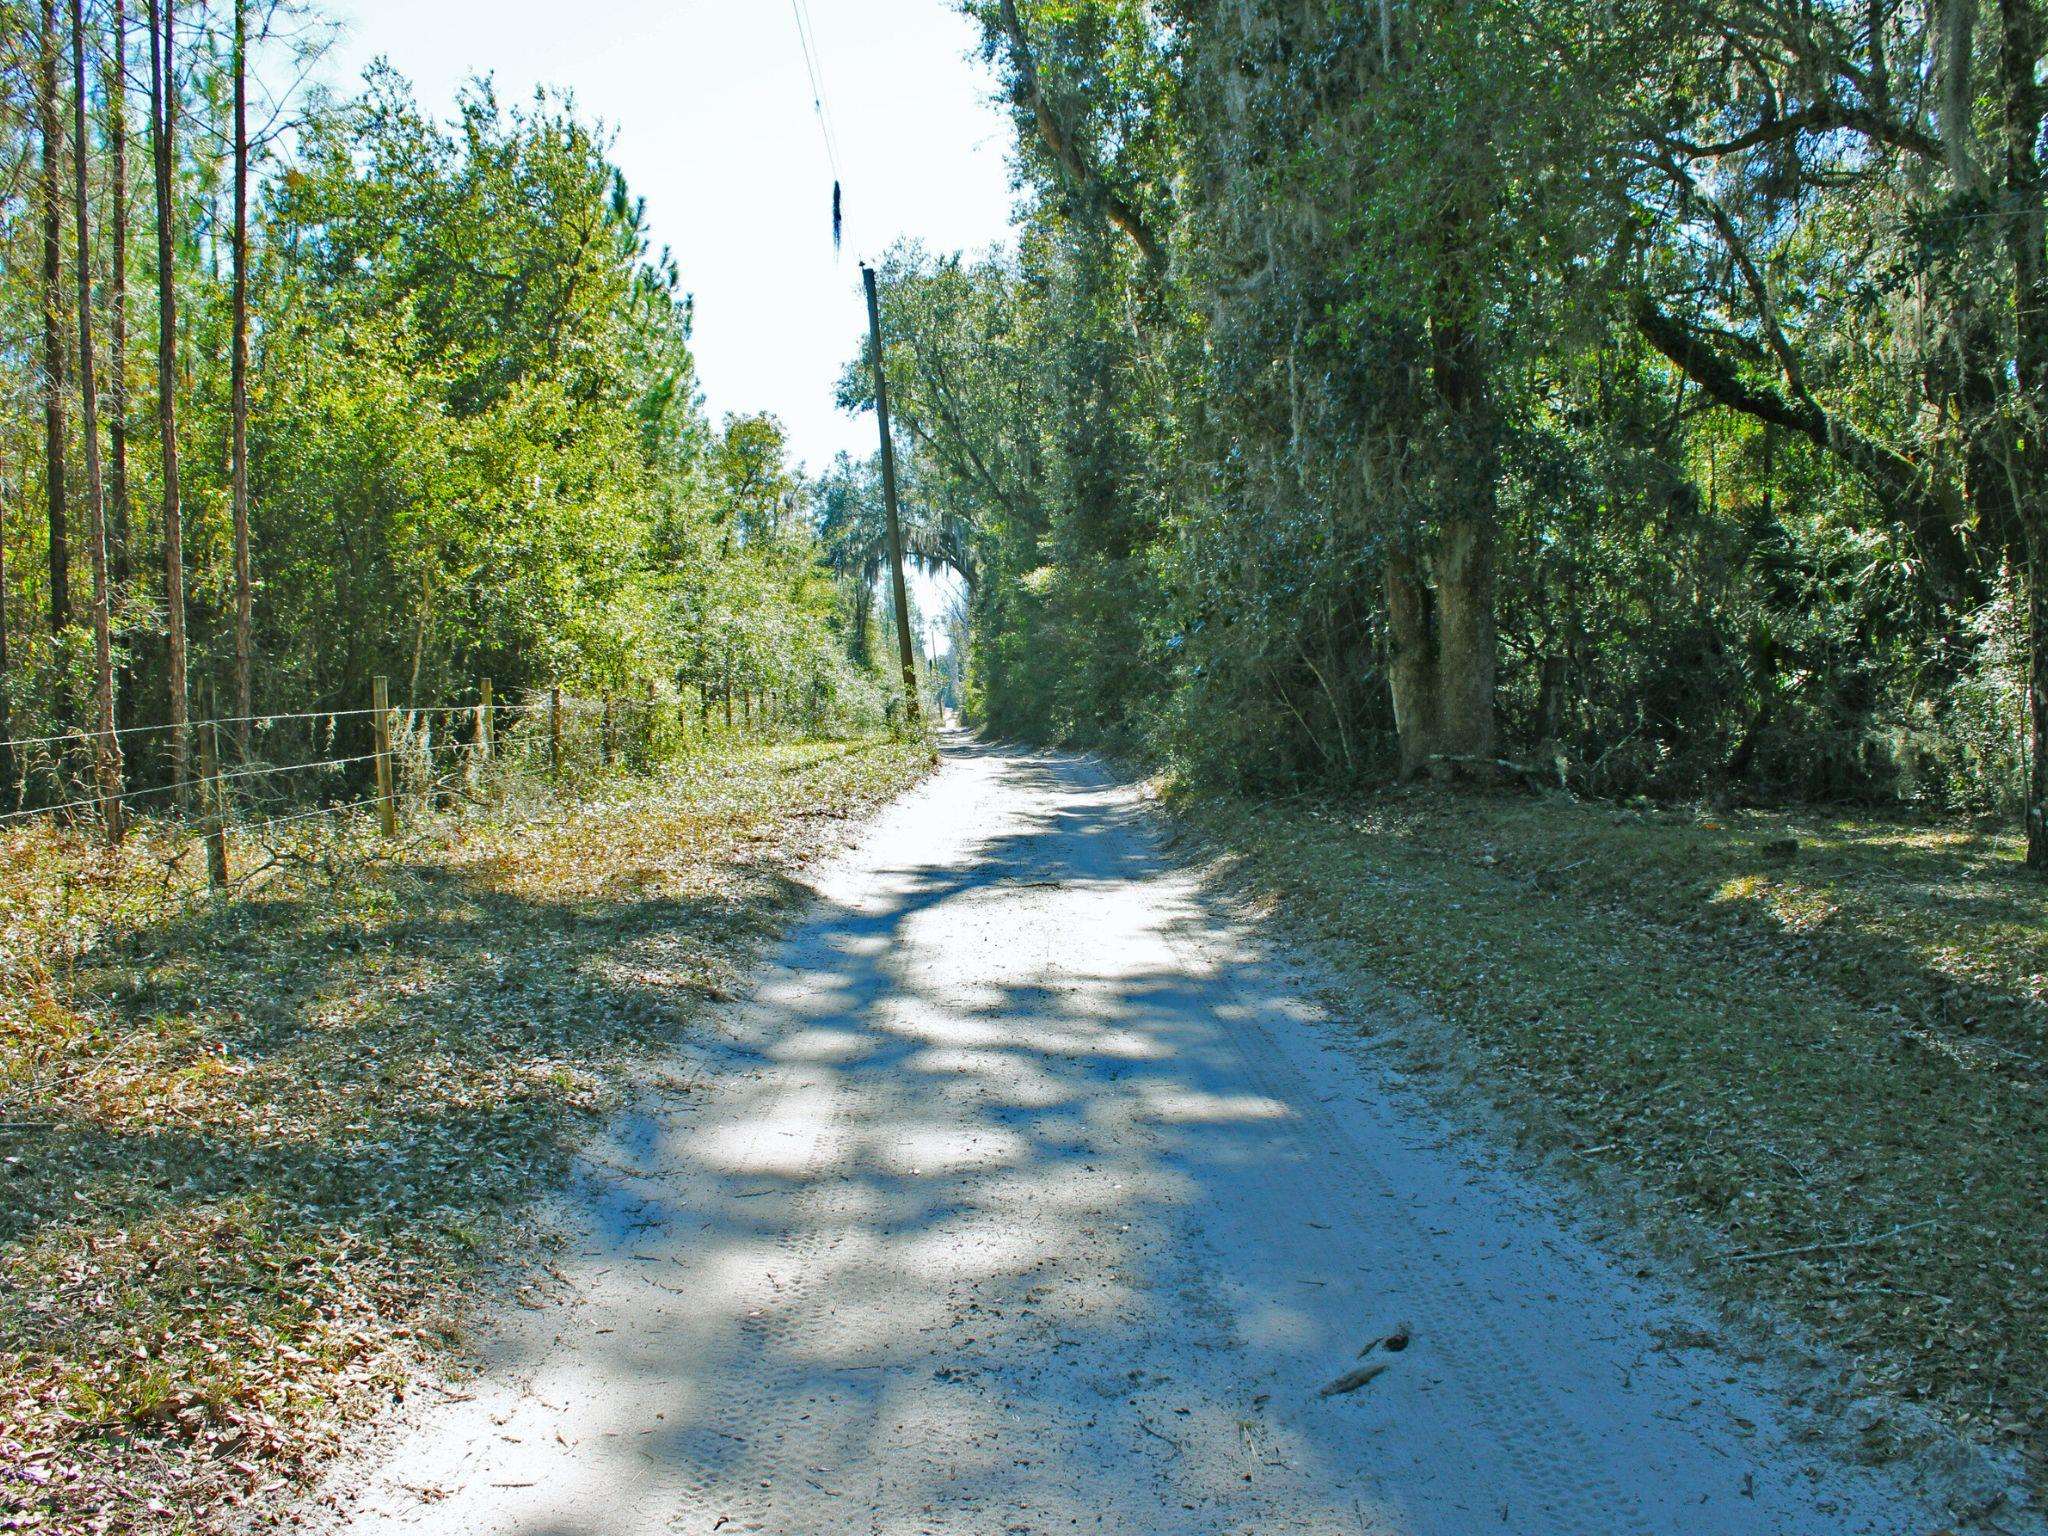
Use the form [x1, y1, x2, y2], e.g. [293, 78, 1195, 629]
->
[0, 741, 930, 1532]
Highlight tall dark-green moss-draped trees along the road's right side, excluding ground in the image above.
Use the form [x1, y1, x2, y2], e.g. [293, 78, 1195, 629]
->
[860, 0, 2048, 868]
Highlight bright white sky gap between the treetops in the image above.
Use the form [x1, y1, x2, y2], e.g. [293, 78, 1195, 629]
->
[328, 0, 1010, 471]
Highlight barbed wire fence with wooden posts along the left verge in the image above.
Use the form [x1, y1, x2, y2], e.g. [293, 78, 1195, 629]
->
[0, 678, 807, 889]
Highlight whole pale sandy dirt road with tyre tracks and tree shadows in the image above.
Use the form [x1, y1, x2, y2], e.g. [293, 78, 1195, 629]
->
[307, 743, 1982, 1536]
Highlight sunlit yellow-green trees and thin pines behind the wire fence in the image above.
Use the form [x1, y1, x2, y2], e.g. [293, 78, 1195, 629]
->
[0, 0, 901, 821]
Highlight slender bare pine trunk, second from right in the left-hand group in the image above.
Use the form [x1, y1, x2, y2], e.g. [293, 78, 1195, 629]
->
[150, 0, 190, 801]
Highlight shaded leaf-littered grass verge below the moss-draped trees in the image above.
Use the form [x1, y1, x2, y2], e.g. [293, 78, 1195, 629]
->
[1169, 793, 2048, 1487]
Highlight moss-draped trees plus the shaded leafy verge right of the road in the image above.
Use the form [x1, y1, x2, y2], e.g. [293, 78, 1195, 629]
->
[842, 0, 2048, 1470]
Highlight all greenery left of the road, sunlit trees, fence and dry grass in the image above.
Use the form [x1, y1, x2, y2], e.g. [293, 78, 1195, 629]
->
[0, 0, 930, 1532]
